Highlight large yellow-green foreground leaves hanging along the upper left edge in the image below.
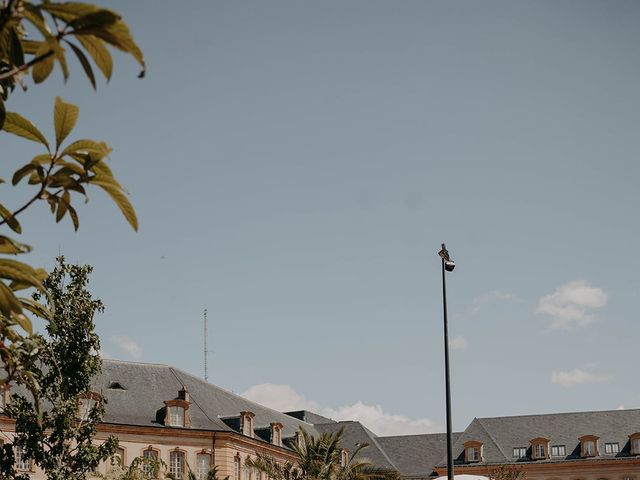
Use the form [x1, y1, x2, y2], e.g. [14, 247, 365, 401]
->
[0, 0, 145, 382]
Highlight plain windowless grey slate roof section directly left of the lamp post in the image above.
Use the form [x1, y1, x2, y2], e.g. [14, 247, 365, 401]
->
[377, 432, 462, 478]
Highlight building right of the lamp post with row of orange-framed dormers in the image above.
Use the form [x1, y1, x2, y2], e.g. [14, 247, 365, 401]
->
[435, 410, 640, 480]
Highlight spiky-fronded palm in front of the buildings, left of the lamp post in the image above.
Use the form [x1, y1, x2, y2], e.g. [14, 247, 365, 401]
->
[246, 428, 400, 480]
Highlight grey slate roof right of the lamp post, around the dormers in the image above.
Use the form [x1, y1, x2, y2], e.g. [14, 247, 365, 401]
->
[438, 409, 640, 466]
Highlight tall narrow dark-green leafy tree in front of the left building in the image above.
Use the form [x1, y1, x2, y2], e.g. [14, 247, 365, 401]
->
[0, 257, 118, 480]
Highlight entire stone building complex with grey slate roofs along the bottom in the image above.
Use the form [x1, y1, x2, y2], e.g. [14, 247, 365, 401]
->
[0, 360, 640, 480]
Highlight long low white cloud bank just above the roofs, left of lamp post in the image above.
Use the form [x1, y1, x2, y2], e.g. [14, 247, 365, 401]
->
[242, 383, 441, 435]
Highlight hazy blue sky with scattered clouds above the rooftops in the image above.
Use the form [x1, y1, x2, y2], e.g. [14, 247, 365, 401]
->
[2, 0, 640, 433]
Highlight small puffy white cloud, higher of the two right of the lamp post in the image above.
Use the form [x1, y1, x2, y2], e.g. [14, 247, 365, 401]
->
[536, 280, 609, 329]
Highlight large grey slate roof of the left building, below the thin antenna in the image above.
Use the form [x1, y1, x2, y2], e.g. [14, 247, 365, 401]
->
[94, 360, 315, 438]
